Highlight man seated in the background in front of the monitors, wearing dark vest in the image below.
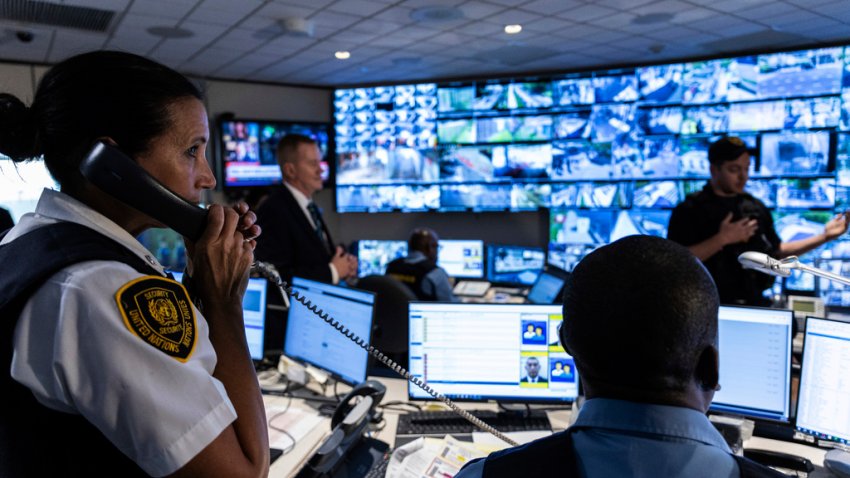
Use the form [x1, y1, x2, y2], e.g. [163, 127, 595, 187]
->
[386, 227, 457, 302]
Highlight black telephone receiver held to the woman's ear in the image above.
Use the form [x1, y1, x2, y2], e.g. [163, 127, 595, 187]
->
[80, 141, 207, 242]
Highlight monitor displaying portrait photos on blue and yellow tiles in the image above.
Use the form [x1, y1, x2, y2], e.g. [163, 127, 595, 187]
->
[408, 302, 578, 403]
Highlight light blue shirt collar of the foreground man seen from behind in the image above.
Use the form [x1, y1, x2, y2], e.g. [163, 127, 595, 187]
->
[573, 398, 730, 452]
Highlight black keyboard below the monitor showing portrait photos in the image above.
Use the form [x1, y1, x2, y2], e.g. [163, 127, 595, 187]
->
[396, 410, 552, 437]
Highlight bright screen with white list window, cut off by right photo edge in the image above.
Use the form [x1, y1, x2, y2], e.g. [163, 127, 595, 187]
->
[797, 317, 850, 445]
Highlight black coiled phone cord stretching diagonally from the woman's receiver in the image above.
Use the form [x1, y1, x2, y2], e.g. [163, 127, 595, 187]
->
[252, 261, 519, 446]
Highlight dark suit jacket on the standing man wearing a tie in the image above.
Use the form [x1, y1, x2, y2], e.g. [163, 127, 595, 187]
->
[254, 186, 336, 283]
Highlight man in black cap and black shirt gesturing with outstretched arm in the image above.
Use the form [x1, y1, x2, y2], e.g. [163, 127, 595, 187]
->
[667, 136, 850, 306]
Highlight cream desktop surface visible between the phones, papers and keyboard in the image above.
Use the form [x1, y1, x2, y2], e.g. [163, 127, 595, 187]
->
[263, 377, 830, 478]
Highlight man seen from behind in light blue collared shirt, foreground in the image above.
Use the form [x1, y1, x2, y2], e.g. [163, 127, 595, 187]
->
[455, 236, 785, 478]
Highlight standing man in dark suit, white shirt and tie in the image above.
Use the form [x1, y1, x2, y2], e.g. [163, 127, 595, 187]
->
[255, 134, 357, 284]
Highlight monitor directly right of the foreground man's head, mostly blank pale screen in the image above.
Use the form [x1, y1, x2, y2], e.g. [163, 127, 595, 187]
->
[710, 306, 794, 423]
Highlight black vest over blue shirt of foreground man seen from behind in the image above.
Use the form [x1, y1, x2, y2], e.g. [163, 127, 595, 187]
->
[476, 430, 786, 478]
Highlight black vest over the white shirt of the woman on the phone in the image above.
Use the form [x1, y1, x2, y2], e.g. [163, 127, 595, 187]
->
[0, 222, 161, 477]
